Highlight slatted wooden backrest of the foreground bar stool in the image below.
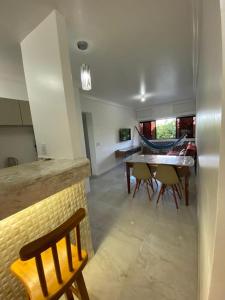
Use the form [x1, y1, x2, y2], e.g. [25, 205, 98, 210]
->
[19, 208, 86, 297]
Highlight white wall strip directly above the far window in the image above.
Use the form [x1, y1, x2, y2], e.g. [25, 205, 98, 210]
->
[137, 100, 196, 121]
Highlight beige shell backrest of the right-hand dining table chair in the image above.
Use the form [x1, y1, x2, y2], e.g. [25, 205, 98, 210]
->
[155, 165, 179, 185]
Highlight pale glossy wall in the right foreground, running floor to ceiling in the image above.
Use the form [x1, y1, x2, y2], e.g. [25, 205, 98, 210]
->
[196, 0, 225, 300]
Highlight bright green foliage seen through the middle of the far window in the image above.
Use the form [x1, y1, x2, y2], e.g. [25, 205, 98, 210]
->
[156, 119, 176, 139]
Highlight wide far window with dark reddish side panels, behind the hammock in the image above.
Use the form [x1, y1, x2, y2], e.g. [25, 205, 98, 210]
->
[140, 116, 195, 140]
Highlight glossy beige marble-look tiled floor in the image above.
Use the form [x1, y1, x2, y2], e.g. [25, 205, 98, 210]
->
[84, 166, 197, 300]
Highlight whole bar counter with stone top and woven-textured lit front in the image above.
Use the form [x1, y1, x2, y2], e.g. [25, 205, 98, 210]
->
[0, 159, 93, 300]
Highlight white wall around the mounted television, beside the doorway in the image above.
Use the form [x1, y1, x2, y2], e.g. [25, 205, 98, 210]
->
[80, 94, 138, 175]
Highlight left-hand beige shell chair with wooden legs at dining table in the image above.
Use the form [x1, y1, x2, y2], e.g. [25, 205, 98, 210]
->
[133, 163, 154, 201]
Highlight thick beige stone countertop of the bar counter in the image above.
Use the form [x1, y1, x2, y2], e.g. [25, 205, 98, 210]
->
[0, 158, 90, 220]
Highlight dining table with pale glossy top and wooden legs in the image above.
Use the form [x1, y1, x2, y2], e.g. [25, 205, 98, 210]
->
[125, 154, 194, 206]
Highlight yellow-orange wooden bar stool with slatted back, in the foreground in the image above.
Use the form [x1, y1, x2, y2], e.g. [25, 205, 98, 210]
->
[11, 208, 89, 300]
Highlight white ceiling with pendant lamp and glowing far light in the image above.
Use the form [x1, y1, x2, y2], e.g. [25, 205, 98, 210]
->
[0, 0, 193, 108]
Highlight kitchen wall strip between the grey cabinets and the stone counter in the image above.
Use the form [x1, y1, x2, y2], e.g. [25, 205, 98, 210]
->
[0, 126, 37, 168]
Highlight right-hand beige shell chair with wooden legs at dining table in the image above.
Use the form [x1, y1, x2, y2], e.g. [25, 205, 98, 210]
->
[155, 165, 181, 209]
